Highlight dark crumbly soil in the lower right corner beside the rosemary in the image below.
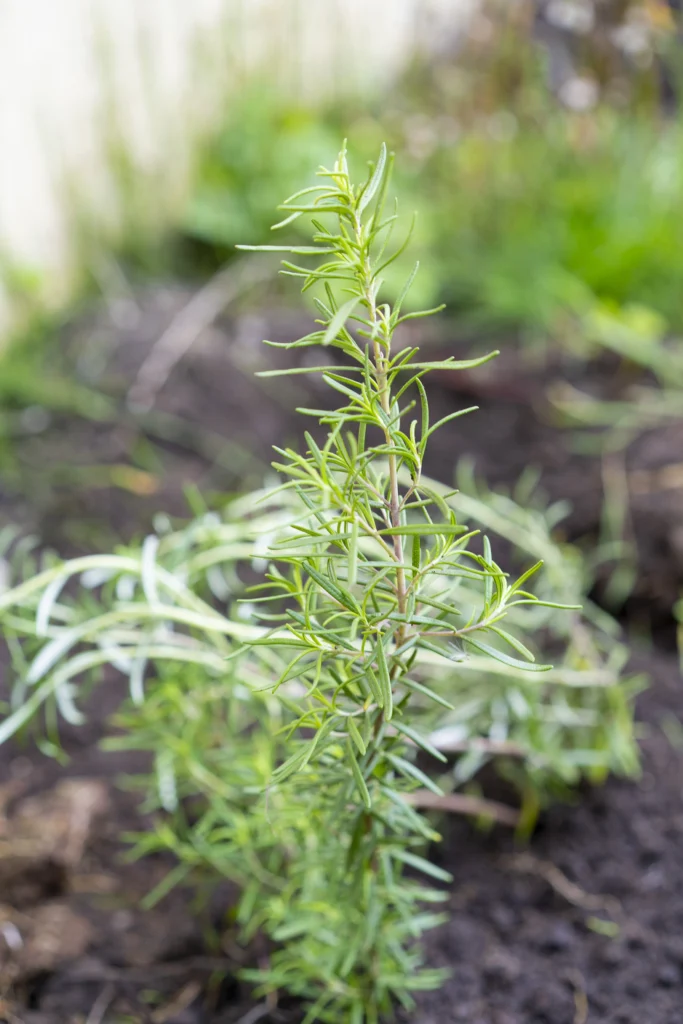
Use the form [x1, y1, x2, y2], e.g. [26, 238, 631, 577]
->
[405, 655, 683, 1024]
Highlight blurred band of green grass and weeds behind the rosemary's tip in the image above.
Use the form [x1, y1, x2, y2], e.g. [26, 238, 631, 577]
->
[181, 16, 683, 340]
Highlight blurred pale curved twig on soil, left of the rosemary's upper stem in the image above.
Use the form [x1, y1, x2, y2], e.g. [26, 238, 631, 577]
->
[128, 257, 272, 413]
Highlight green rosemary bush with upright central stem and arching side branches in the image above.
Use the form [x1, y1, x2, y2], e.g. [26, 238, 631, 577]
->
[0, 147, 637, 1024]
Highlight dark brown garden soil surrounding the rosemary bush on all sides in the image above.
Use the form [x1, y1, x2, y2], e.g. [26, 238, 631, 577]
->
[0, 290, 683, 1024]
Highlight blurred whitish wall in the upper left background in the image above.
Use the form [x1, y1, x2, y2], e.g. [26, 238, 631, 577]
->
[0, 0, 476, 331]
